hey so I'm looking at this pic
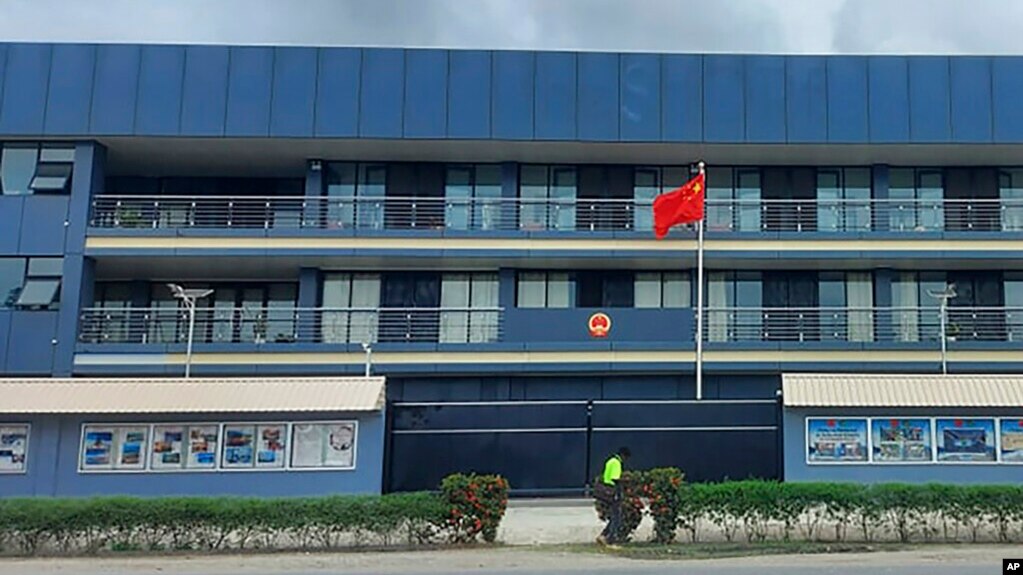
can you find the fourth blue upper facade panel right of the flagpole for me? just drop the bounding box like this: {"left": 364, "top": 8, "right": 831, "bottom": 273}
{"left": 828, "top": 56, "right": 869, "bottom": 143}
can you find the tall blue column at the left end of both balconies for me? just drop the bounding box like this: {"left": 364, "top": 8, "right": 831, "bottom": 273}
{"left": 53, "top": 142, "right": 106, "bottom": 378}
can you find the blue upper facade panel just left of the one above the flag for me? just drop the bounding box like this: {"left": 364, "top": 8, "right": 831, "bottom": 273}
{"left": 618, "top": 54, "right": 661, "bottom": 142}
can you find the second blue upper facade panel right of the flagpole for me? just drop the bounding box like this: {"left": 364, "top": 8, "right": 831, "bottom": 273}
{"left": 746, "top": 56, "right": 787, "bottom": 143}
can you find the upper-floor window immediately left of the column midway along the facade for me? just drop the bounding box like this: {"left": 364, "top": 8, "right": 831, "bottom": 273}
{"left": 444, "top": 165, "right": 501, "bottom": 230}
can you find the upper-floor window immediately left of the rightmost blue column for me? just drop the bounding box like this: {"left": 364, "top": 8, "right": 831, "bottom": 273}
{"left": 817, "top": 168, "right": 871, "bottom": 231}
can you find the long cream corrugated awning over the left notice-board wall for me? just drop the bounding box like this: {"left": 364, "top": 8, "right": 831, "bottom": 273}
{"left": 0, "top": 378, "right": 385, "bottom": 413}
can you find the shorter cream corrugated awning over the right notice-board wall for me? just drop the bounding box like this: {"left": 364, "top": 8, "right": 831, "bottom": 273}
{"left": 782, "top": 373, "right": 1023, "bottom": 407}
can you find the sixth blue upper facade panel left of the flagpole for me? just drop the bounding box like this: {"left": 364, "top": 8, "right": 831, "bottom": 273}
{"left": 447, "top": 50, "right": 492, "bottom": 139}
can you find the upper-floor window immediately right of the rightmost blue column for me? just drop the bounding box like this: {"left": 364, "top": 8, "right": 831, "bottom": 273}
{"left": 887, "top": 168, "right": 945, "bottom": 231}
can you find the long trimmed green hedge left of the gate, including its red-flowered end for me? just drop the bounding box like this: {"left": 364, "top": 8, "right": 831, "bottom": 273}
{"left": 0, "top": 476, "right": 507, "bottom": 555}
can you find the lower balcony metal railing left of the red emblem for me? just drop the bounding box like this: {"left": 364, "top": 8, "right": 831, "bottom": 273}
{"left": 79, "top": 307, "right": 503, "bottom": 345}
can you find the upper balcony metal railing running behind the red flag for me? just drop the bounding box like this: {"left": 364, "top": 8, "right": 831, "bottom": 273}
{"left": 90, "top": 195, "right": 1023, "bottom": 233}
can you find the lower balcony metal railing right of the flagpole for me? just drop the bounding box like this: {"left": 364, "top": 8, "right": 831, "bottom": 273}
{"left": 704, "top": 307, "right": 1023, "bottom": 343}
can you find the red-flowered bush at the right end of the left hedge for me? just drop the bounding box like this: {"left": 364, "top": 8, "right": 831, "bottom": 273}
{"left": 441, "top": 474, "right": 508, "bottom": 543}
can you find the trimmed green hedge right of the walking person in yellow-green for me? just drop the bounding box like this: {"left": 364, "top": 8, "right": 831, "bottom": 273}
{"left": 597, "top": 476, "right": 1023, "bottom": 543}
